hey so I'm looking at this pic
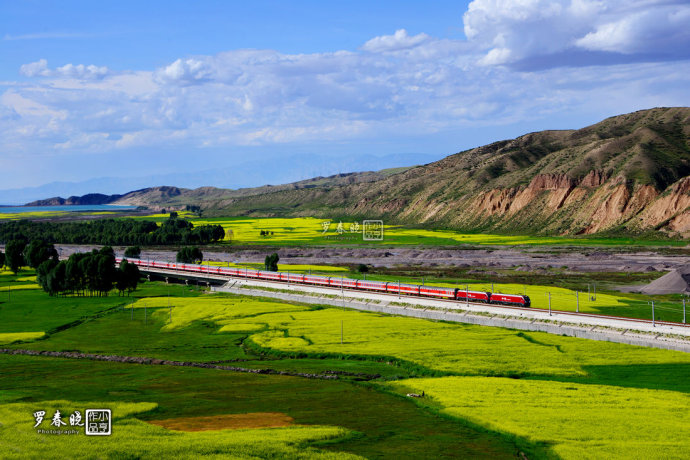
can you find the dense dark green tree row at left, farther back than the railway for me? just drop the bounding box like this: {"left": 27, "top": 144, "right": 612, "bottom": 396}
{"left": 0, "top": 215, "right": 225, "bottom": 246}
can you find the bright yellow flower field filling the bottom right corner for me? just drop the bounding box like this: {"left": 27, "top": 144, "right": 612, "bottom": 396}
{"left": 390, "top": 377, "right": 690, "bottom": 459}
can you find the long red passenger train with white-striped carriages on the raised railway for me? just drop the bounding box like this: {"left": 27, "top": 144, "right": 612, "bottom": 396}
{"left": 116, "top": 258, "right": 530, "bottom": 307}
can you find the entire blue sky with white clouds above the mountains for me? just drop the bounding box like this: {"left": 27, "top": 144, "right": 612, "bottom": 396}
{"left": 0, "top": 0, "right": 690, "bottom": 196}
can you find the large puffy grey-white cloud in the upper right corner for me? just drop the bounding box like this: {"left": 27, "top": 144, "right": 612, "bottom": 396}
{"left": 463, "top": 0, "right": 690, "bottom": 67}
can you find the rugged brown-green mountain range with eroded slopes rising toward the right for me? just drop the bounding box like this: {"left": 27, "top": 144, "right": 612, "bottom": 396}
{"left": 18, "top": 107, "right": 690, "bottom": 236}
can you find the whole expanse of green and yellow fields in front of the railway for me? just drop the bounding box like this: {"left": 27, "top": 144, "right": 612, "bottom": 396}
{"left": 0, "top": 273, "right": 690, "bottom": 459}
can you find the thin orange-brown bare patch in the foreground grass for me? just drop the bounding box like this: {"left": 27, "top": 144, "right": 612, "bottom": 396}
{"left": 149, "top": 412, "right": 294, "bottom": 431}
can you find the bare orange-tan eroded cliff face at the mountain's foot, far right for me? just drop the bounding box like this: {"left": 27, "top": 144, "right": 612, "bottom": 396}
{"left": 460, "top": 171, "right": 690, "bottom": 236}
